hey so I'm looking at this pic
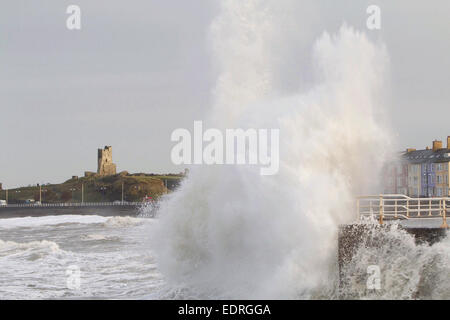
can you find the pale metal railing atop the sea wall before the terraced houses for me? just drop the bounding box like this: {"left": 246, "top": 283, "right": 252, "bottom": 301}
{"left": 356, "top": 194, "right": 450, "bottom": 228}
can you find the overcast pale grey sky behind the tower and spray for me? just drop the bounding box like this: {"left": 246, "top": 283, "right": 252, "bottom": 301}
{"left": 0, "top": 0, "right": 450, "bottom": 188}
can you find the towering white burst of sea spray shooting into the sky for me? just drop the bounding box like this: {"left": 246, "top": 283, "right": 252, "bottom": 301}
{"left": 151, "top": 1, "right": 390, "bottom": 298}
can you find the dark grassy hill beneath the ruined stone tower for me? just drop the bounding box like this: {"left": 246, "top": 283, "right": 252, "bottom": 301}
{"left": 0, "top": 172, "right": 184, "bottom": 203}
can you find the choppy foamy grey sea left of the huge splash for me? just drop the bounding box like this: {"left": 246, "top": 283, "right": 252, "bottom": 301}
{"left": 0, "top": 215, "right": 162, "bottom": 299}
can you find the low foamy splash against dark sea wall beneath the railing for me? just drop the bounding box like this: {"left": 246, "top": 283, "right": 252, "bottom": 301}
{"left": 338, "top": 222, "right": 450, "bottom": 299}
